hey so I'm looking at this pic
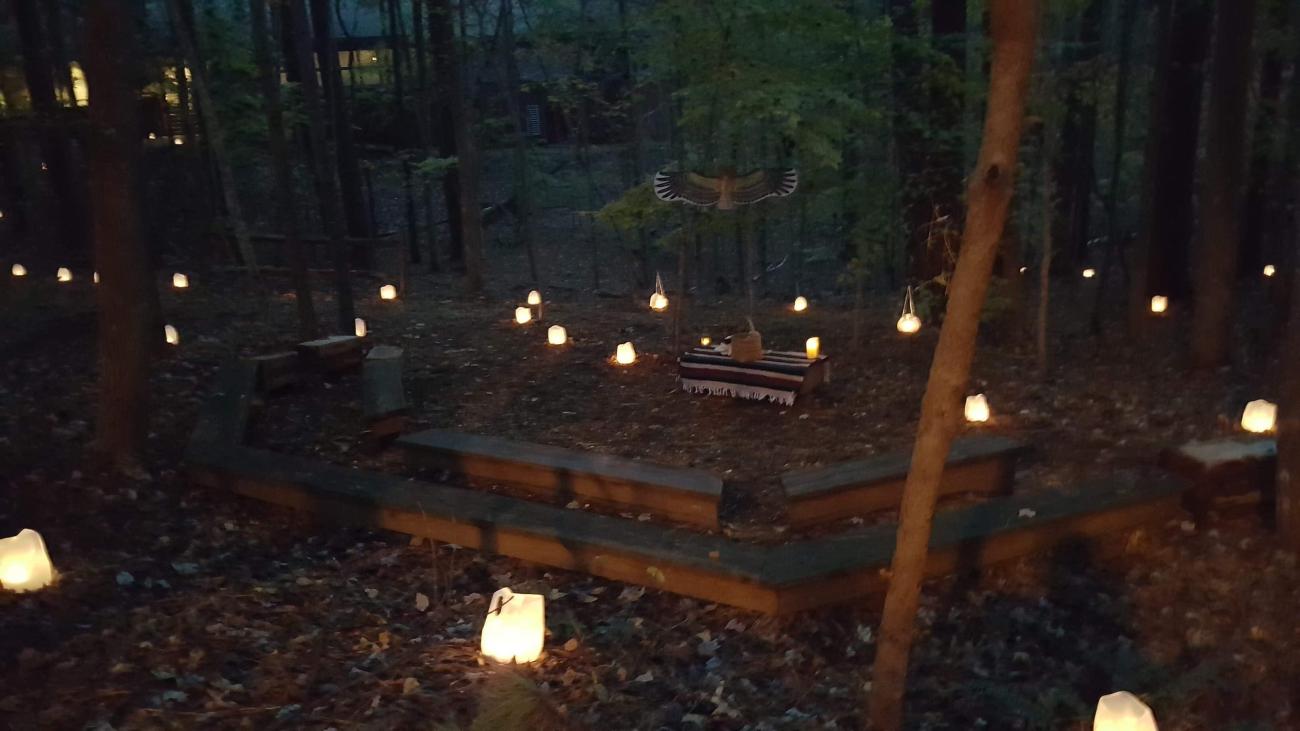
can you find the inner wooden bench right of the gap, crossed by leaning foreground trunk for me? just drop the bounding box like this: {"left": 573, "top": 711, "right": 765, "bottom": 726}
{"left": 781, "top": 434, "right": 1028, "bottom": 528}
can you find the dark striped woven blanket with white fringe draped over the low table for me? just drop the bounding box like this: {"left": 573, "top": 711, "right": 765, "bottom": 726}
{"left": 677, "top": 346, "right": 831, "bottom": 406}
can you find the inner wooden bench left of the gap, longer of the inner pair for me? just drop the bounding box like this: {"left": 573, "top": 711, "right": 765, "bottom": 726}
{"left": 397, "top": 429, "right": 723, "bottom": 528}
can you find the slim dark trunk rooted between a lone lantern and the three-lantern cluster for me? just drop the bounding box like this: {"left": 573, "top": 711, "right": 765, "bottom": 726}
{"left": 429, "top": 0, "right": 484, "bottom": 294}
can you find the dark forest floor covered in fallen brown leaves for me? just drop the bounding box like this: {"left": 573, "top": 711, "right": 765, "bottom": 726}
{"left": 0, "top": 256, "right": 1300, "bottom": 731}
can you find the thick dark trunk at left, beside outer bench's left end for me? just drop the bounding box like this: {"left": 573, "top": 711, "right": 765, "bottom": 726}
{"left": 85, "top": 0, "right": 161, "bottom": 471}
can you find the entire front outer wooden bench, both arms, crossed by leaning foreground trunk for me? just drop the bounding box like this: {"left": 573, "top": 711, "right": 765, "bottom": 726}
{"left": 186, "top": 441, "right": 1186, "bottom": 614}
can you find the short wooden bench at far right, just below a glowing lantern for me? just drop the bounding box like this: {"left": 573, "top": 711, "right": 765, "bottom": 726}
{"left": 1160, "top": 438, "right": 1278, "bottom": 523}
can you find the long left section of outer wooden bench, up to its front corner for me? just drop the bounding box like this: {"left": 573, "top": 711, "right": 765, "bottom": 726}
{"left": 186, "top": 444, "right": 777, "bottom": 613}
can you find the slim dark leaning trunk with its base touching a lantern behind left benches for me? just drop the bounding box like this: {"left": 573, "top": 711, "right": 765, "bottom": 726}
{"left": 286, "top": 0, "right": 356, "bottom": 327}
